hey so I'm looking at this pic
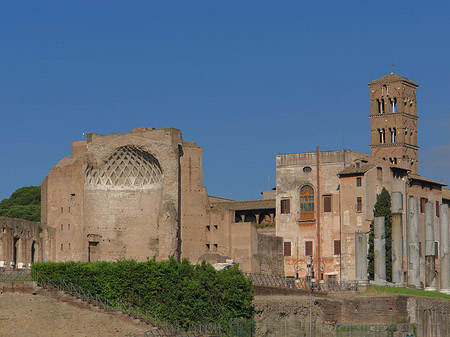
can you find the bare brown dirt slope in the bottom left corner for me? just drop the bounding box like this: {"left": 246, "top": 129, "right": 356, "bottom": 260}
{"left": 0, "top": 293, "right": 149, "bottom": 337}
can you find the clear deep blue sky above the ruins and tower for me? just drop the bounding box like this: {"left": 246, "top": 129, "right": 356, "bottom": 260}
{"left": 0, "top": 0, "right": 450, "bottom": 200}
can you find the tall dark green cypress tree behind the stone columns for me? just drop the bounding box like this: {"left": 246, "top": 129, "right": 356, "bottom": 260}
{"left": 367, "top": 187, "right": 392, "bottom": 282}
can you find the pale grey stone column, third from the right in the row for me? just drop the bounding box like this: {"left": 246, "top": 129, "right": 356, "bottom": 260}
{"left": 408, "top": 197, "right": 420, "bottom": 288}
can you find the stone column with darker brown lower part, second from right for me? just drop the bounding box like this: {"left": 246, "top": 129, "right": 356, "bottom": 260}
{"left": 425, "top": 202, "right": 436, "bottom": 291}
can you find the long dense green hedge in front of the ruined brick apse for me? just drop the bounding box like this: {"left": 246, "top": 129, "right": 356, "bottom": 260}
{"left": 33, "top": 258, "right": 254, "bottom": 327}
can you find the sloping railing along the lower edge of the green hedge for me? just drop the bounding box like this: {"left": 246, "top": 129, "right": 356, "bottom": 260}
{"left": 30, "top": 270, "right": 221, "bottom": 337}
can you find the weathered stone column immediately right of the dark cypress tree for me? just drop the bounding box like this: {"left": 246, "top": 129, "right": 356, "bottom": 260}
{"left": 391, "top": 192, "right": 404, "bottom": 284}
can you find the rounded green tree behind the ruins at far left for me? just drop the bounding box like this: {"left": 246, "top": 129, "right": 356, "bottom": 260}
{"left": 0, "top": 186, "right": 41, "bottom": 222}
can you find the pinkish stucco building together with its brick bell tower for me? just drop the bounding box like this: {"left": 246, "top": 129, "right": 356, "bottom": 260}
{"left": 276, "top": 74, "right": 450, "bottom": 281}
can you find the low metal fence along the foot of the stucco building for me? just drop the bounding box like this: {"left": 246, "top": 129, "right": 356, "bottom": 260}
{"left": 245, "top": 273, "right": 359, "bottom": 291}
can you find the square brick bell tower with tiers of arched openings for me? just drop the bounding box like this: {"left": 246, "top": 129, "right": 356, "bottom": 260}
{"left": 369, "top": 73, "right": 419, "bottom": 174}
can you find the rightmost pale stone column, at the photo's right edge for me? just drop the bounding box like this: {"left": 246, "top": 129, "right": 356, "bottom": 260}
{"left": 439, "top": 204, "right": 450, "bottom": 294}
